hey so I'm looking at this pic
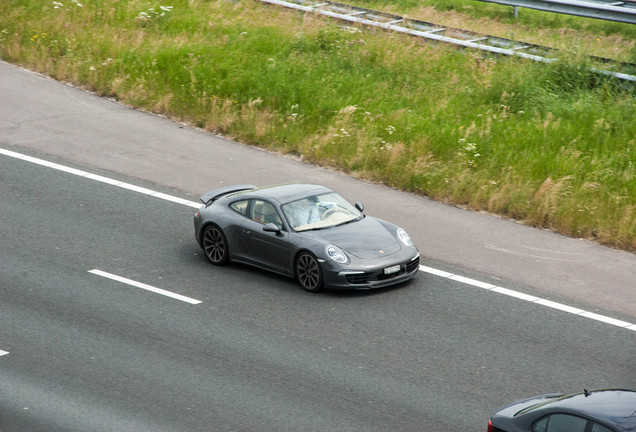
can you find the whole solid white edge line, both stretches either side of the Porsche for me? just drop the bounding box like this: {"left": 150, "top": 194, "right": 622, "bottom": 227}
{"left": 0, "top": 148, "right": 636, "bottom": 331}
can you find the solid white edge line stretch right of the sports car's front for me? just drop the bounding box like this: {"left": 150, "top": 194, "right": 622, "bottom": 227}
{"left": 420, "top": 265, "right": 636, "bottom": 331}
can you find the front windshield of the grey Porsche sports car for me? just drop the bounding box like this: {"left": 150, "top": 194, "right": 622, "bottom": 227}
{"left": 282, "top": 192, "right": 362, "bottom": 231}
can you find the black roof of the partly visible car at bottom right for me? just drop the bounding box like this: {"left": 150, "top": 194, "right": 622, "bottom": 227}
{"left": 517, "top": 389, "right": 636, "bottom": 430}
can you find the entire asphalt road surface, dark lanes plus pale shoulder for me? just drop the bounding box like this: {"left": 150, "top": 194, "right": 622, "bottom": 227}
{"left": 0, "top": 63, "right": 636, "bottom": 432}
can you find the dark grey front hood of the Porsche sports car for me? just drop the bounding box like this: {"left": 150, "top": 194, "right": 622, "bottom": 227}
{"left": 303, "top": 216, "right": 400, "bottom": 259}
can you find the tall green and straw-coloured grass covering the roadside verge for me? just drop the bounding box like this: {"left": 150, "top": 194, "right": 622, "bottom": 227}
{"left": 0, "top": 0, "right": 636, "bottom": 251}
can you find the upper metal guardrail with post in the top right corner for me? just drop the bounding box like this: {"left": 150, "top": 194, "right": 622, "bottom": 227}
{"left": 479, "top": 0, "right": 636, "bottom": 24}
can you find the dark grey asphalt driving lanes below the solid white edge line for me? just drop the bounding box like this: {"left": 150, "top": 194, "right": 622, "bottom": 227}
{"left": 0, "top": 143, "right": 636, "bottom": 432}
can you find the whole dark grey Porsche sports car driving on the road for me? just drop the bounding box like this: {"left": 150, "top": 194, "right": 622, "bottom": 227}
{"left": 194, "top": 184, "right": 420, "bottom": 292}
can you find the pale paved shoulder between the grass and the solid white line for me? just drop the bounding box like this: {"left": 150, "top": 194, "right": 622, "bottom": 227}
{"left": 0, "top": 58, "right": 636, "bottom": 322}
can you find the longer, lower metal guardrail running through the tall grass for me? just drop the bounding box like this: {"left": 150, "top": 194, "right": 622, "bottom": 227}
{"left": 259, "top": 0, "right": 636, "bottom": 82}
